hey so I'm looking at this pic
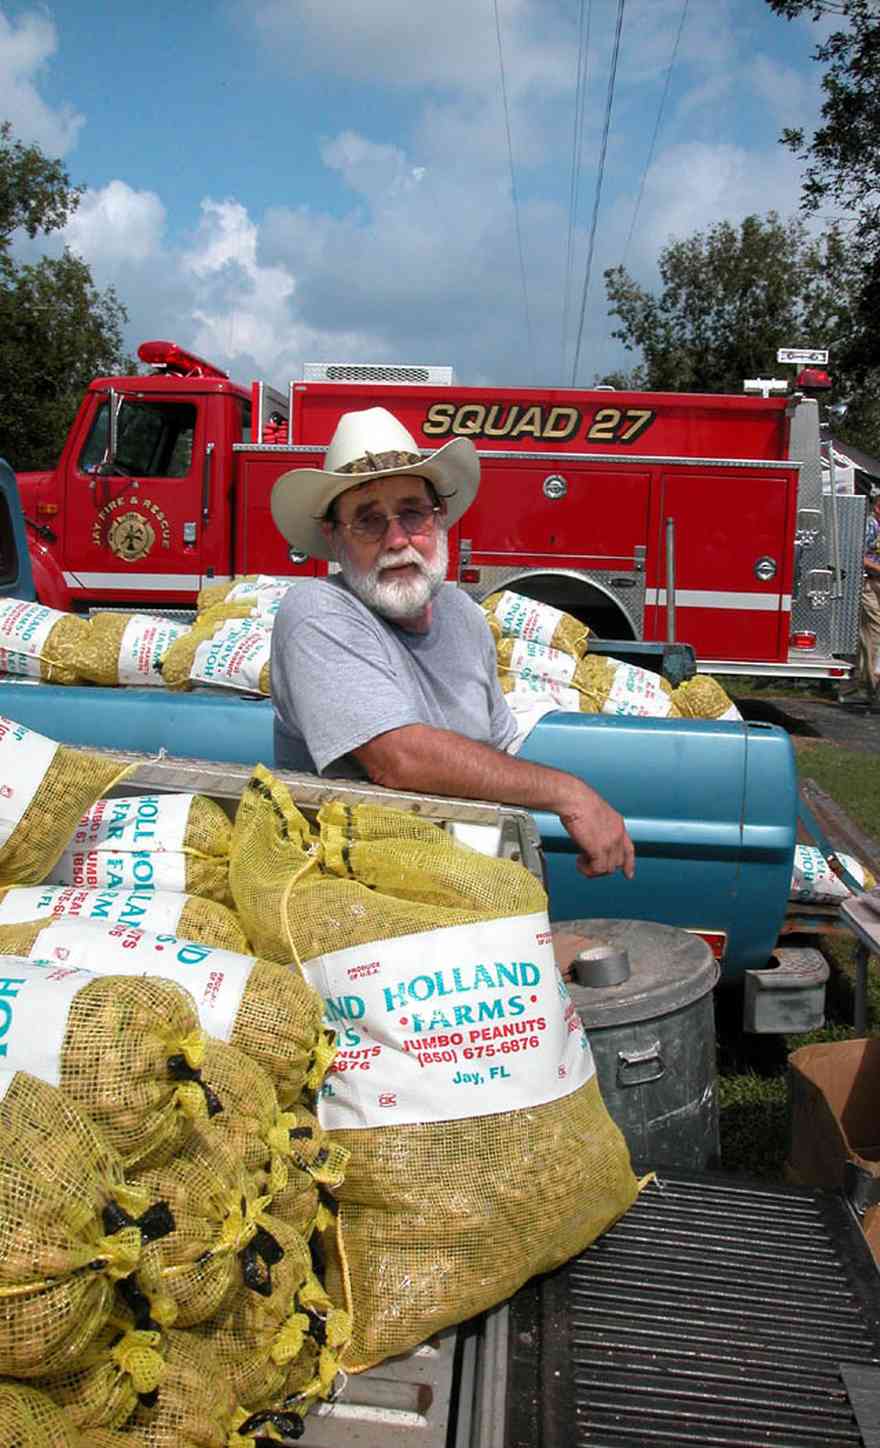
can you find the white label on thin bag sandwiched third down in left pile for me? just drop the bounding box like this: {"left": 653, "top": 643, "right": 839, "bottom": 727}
{"left": 0, "top": 885, "right": 190, "bottom": 934}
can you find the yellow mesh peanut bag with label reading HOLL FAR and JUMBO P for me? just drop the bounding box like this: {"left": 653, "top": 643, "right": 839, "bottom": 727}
{"left": 45, "top": 788, "right": 232, "bottom": 904}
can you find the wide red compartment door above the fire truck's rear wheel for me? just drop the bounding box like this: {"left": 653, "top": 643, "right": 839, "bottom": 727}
{"left": 462, "top": 453, "right": 650, "bottom": 571}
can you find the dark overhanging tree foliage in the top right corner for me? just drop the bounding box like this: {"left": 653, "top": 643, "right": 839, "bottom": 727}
{"left": 767, "top": 0, "right": 880, "bottom": 388}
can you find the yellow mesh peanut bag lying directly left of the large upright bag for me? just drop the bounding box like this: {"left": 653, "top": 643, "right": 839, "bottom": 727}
{"left": 0, "top": 917, "right": 333, "bottom": 1106}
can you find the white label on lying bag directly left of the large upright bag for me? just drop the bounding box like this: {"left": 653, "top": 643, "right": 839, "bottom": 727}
{"left": 29, "top": 919, "right": 253, "bottom": 1041}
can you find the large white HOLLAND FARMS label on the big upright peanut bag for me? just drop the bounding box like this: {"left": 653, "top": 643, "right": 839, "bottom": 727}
{"left": 303, "top": 912, "right": 595, "bottom": 1131}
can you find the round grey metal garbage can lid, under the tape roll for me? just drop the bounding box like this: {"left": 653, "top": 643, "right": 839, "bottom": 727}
{"left": 551, "top": 919, "right": 721, "bottom": 1030}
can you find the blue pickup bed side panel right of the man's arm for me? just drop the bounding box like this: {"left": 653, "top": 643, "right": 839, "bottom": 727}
{"left": 520, "top": 712, "right": 798, "bottom": 980}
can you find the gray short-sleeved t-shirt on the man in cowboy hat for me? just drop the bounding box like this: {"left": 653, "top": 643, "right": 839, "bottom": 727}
{"left": 272, "top": 576, "right": 517, "bottom": 778}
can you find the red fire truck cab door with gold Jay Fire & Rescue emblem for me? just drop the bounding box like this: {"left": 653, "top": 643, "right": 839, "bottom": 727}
{"left": 64, "top": 397, "right": 205, "bottom": 602}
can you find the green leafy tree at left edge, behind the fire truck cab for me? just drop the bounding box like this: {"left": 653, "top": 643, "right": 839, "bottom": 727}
{"left": 0, "top": 123, "right": 132, "bottom": 469}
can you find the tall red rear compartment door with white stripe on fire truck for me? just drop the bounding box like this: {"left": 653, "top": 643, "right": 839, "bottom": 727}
{"left": 646, "top": 469, "right": 796, "bottom": 662}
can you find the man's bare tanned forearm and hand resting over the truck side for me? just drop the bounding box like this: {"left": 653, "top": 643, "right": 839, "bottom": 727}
{"left": 355, "top": 724, "right": 634, "bottom": 876}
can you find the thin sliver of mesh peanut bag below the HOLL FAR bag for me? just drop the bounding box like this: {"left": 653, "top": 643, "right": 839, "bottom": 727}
{"left": 0, "top": 885, "right": 250, "bottom": 954}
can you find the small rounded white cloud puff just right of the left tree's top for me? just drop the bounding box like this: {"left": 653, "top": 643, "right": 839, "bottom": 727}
{"left": 64, "top": 181, "right": 165, "bottom": 271}
